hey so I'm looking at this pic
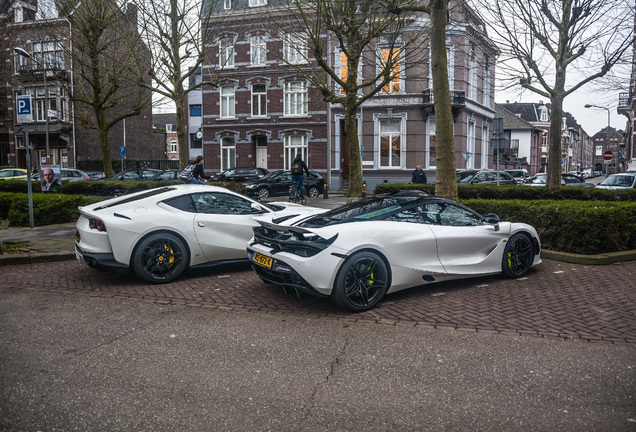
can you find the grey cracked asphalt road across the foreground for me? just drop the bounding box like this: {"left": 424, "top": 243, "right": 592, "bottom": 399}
{"left": 0, "top": 278, "right": 636, "bottom": 431}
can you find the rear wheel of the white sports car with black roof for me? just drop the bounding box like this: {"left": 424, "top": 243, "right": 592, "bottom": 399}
{"left": 331, "top": 251, "right": 390, "bottom": 312}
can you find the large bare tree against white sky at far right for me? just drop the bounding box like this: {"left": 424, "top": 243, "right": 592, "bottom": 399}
{"left": 475, "top": 0, "right": 634, "bottom": 187}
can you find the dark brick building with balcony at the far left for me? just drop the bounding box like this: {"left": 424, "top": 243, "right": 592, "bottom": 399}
{"left": 0, "top": 0, "right": 163, "bottom": 169}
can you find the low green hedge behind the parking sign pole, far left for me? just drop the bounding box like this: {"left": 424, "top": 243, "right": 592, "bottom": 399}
{"left": 7, "top": 192, "right": 99, "bottom": 226}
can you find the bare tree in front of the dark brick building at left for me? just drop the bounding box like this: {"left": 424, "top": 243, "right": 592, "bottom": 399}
{"left": 59, "top": 0, "right": 151, "bottom": 176}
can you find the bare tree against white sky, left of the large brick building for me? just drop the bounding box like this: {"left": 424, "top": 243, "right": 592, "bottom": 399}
{"left": 133, "top": 0, "right": 238, "bottom": 169}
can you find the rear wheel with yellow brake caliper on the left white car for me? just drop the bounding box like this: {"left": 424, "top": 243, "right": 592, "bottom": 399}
{"left": 133, "top": 232, "right": 189, "bottom": 283}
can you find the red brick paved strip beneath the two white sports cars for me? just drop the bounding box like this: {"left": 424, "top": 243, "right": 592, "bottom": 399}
{"left": 2, "top": 261, "right": 636, "bottom": 344}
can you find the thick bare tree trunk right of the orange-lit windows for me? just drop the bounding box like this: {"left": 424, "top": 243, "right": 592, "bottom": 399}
{"left": 431, "top": 0, "right": 458, "bottom": 200}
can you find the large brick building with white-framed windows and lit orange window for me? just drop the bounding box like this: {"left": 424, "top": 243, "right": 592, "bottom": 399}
{"left": 202, "top": 0, "right": 498, "bottom": 189}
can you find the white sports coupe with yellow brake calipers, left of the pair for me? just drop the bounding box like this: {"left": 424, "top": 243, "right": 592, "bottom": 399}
{"left": 75, "top": 185, "right": 324, "bottom": 283}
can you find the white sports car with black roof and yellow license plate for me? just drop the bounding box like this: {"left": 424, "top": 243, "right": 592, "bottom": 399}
{"left": 247, "top": 191, "right": 541, "bottom": 311}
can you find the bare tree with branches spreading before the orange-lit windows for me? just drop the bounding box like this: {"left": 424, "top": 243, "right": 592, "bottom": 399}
{"left": 279, "top": 0, "right": 428, "bottom": 196}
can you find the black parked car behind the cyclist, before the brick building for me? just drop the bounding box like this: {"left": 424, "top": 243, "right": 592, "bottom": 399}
{"left": 245, "top": 170, "right": 325, "bottom": 199}
